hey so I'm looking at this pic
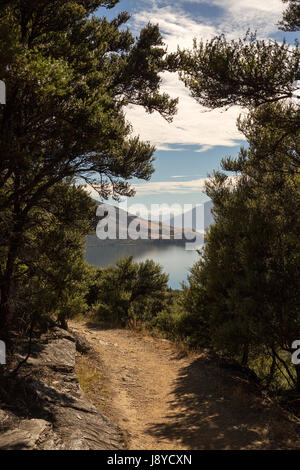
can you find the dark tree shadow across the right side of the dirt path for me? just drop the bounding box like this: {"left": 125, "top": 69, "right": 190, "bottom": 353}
{"left": 148, "top": 357, "right": 296, "bottom": 450}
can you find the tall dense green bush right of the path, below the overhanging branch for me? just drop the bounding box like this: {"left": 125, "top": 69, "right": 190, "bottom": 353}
{"left": 185, "top": 111, "right": 300, "bottom": 386}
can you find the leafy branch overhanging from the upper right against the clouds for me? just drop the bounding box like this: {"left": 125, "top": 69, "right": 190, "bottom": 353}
{"left": 169, "top": 35, "right": 300, "bottom": 109}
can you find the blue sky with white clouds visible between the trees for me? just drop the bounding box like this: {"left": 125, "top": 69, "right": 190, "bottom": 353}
{"left": 97, "top": 0, "right": 295, "bottom": 213}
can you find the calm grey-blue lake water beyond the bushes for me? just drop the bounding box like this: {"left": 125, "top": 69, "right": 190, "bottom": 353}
{"left": 86, "top": 242, "right": 199, "bottom": 289}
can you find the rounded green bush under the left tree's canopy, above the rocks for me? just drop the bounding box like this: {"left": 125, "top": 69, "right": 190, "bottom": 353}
{"left": 0, "top": 183, "right": 96, "bottom": 325}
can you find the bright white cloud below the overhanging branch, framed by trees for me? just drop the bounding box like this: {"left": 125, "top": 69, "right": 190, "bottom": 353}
{"left": 127, "top": 72, "right": 243, "bottom": 152}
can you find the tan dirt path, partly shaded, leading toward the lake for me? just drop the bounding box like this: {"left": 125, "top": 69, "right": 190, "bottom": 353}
{"left": 70, "top": 322, "right": 300, "bottom": 450}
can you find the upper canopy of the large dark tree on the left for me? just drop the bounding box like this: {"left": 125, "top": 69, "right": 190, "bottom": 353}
{"left": 0, "top": 1, "right": 176, "bottom": 200}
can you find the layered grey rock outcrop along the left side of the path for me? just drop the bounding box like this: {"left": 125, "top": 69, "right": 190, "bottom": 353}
{"left": 0, "top": 328, "right": 124, "bottom": 450}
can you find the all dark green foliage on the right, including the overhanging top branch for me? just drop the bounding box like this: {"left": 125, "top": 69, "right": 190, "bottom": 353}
{"left": 173, "top": 1, "right": 300, "bottom": 390}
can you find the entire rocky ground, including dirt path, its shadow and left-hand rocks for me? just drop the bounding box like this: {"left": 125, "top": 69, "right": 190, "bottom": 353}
{"left": 0, "top": 322, "right": 300, "bottom": 450}
